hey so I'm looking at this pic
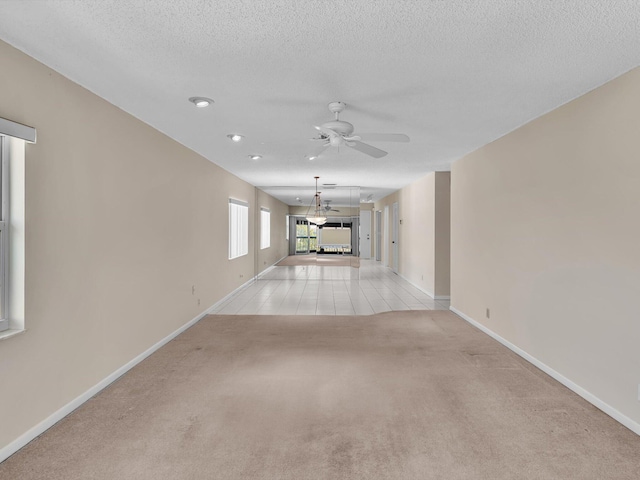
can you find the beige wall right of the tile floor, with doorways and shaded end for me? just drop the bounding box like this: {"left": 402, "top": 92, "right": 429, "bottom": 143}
{"left": 374, "top": 172, "right": 451, "bottom": 297}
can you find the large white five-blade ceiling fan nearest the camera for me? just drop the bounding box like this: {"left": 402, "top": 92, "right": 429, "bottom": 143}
{"left": 308, "top": 102, "right": 409, "bottom": 160}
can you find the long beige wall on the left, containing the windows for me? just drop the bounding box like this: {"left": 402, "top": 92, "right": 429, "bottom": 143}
{"left": 0, "top": 42, "right": 286, "bottom": 448}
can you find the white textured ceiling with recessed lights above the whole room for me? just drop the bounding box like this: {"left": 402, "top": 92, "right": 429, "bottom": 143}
{"left": 0, "top": 0, "right": 640, "bottom": 205}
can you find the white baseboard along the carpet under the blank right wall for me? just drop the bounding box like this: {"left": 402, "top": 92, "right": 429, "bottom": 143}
{"left": 449, "top": 307, "right": 640, "bottom": 435}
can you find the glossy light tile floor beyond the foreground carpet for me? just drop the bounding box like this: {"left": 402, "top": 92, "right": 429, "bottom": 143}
{"left": 211, "top": 260, "right": 449, "bottom": 315}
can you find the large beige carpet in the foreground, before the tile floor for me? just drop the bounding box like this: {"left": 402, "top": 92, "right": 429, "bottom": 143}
{"left": 0, "top": 311, "right": 640, "bottom": 480}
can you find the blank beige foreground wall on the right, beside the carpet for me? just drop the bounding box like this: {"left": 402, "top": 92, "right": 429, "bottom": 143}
{"left": 451, "top": 65, "right": 640, "bottom": 430}
